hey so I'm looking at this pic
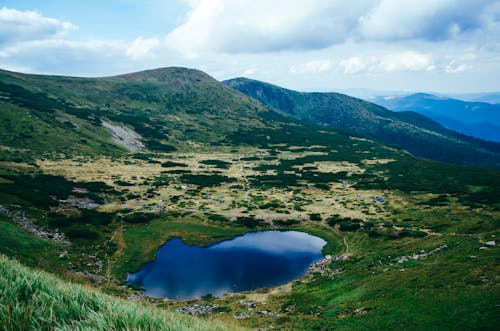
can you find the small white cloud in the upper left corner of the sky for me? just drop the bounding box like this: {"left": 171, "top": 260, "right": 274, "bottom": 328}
{"left": 0, "top": 7, "right": 76, "bottom": 45}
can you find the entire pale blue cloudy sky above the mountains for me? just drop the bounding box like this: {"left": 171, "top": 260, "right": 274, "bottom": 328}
{"left": 0, "top": 0, "right": 500, "bottom": 93}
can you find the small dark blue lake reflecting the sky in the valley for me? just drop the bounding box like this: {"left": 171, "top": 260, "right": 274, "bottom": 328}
{"left": 127, "top": 231, "right": 326, "bottom": 300}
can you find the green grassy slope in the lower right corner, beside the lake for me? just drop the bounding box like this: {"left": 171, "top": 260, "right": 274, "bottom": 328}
{"left": 283, "top": 234, "right": 500, "bottom": 330}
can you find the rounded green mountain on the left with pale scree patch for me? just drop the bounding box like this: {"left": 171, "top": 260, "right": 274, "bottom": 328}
{"left": 0, "top": 68, "right": 282, "bottom": 160}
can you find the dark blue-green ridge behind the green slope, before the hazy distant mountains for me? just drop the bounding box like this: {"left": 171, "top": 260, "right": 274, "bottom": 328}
{"left": 224, "top": 78, "right": 500, "bottom": 167}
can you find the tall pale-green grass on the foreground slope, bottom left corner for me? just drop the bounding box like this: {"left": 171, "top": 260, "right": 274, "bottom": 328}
{"left": 0, "top": 255, "right": 240, "bottom": 331}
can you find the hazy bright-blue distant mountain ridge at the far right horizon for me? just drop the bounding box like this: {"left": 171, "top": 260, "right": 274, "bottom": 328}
{"left": 373, "top": 93, "right": 500, "bottom": 142}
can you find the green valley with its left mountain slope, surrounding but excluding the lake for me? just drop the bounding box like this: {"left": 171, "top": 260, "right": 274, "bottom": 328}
{"left": 0, "top": 68, "right": 500, "bottom": 330}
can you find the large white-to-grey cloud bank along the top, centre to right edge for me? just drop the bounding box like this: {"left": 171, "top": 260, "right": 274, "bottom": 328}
{"left": 168, "top": 0, "right": 498, "bottom": 55}
